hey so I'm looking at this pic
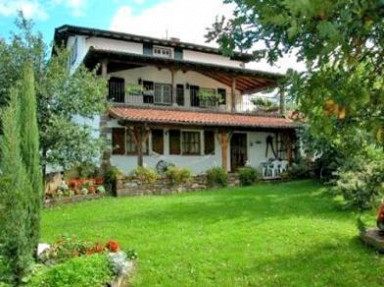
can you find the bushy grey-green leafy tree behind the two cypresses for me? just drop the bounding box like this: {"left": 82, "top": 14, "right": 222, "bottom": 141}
{"left": 0, "top": 15, "right": 107, "bottom": 177}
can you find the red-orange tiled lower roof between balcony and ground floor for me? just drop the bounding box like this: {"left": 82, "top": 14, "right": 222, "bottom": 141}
{"left": 109, "top": 107, "right": 297, "bottom": 129}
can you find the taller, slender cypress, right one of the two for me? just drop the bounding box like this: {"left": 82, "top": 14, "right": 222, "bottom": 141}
{"left": 19, "top": 63, "right": 43, "bottom": 254}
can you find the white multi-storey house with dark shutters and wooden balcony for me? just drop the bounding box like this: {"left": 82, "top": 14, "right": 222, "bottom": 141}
{"left": 55, "top": 25, "right": 297, "bottom": 177}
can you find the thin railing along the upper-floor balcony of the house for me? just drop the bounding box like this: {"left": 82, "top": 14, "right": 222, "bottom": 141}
{"left": 109, "top": 92, "right": 262, "bottom": 113}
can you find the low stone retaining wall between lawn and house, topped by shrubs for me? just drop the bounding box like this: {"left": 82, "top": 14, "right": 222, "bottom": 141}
{"left": 116, "top": 174, "right": 240, "bottom": 196}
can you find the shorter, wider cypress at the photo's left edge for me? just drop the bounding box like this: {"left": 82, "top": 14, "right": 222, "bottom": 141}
{"left": 0, "top": 92, "right": 32, "bottom": 285}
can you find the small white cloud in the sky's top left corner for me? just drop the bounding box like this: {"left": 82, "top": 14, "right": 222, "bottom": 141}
{"left": 0, "top": 0, "right": 48, "bottom": 20}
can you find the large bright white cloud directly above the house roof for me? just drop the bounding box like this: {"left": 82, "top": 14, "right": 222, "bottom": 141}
{"left": 110, "top": 0, "right": 304, "bottom": 73}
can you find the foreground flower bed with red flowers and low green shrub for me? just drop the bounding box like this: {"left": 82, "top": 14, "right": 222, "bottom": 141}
{"left": 27, "top": 237, "right": 137, "bottom": 287}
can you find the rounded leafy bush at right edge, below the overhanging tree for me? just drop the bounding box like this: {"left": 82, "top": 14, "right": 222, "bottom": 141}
{"left": 332, "top": 147, "right": 384, "bottom": 210}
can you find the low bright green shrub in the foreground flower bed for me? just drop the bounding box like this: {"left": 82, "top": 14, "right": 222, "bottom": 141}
{"left": 28, "top": 254, "right": 113, "bottom": 287}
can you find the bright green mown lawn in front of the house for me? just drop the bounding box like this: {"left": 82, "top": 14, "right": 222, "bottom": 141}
{"left": 42, "top": 181, "right": 384, "bottom": 287}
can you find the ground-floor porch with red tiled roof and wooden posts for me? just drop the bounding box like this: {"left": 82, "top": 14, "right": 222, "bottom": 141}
{"left": 107, "top": 107, "right": 297, "bottom": 177}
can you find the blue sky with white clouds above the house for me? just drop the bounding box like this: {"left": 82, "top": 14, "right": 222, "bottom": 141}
{"left": 0, "top": 0, "right": 303, "bottom": 73}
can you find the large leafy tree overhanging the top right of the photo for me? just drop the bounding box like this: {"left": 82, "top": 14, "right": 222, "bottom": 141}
{"left": 206, "top": 0, "right": 384, "bottom": 154}
